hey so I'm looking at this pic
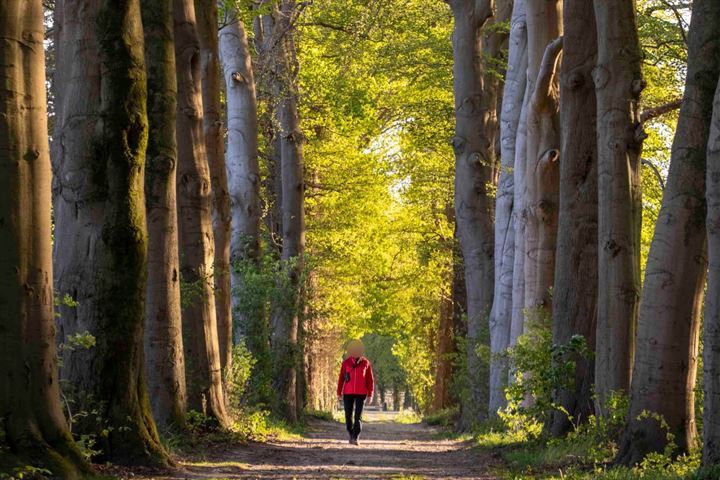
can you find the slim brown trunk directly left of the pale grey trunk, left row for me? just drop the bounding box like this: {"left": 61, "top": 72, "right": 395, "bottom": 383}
{"left": 195, "top": 0, "right": 232, "bottom": 372}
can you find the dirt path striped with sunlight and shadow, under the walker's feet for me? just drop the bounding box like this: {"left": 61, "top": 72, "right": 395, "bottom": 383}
{"left": 115, "top": 411, "right": 499, "bottom": 480}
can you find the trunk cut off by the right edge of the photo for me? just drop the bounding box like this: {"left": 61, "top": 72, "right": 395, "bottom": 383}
{"left": 702, "top": 72, "right": 720, "bottom": 467}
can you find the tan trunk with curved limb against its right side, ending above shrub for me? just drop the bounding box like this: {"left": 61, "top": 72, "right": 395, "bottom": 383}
{"left": 524, "top": 0, "right": 562, "bottom": 314}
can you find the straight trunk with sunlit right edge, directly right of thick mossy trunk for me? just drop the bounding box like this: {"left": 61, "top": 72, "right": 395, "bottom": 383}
{"left": 142, "top": 0, "right": 187, "bottom": 430}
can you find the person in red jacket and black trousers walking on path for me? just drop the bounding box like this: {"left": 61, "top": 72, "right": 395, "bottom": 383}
{"left": 337, "top": 339, "right": 375, "bottom": 445}
